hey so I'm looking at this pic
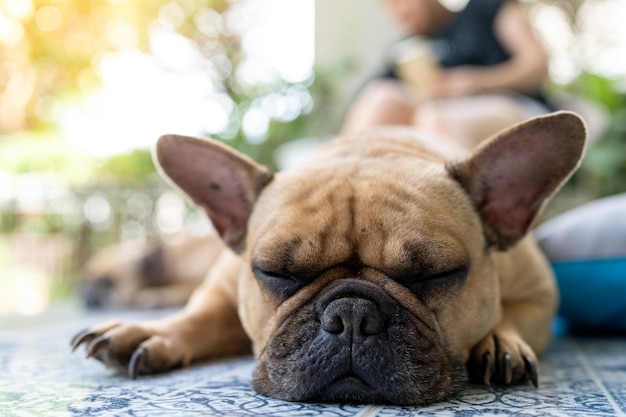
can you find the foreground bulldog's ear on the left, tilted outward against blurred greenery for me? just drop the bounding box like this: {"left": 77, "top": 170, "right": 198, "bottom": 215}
{"left": 154, "top": 135, "right": 274, "bottom": 252}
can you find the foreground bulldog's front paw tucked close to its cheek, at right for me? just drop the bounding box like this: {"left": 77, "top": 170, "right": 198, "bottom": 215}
{"left": 467, "top": 331, "right": 539, "bottom": 387}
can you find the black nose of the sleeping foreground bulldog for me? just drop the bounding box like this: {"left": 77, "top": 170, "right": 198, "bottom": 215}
{"left": 320, "top": 297, "right": 385, "bottom": 343}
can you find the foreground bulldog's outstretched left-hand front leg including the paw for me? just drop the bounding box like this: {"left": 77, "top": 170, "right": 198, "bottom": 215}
{"left": 72, "top": 250, "right": 250, "bottom": 378}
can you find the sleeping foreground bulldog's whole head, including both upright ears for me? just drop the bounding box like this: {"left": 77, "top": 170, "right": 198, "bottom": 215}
{"left": 156, "top": 113, "right": 585, "bottom": 404}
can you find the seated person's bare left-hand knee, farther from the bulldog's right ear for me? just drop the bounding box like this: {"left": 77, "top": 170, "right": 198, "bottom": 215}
{"left": 341, "top": 79, "right": 415, "bottom": 133}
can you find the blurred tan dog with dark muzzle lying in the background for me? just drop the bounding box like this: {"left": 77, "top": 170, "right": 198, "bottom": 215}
{"left": 80, "top": 234, "right": 219, "bottom": 309}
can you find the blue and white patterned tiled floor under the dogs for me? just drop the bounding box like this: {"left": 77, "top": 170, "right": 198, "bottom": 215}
{"left": 0, "top": 306, "right": 626, "bottom": 417}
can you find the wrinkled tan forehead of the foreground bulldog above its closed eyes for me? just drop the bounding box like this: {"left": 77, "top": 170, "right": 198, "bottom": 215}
{"left": 249, "top": 164, "right": 480, "bottom": 272}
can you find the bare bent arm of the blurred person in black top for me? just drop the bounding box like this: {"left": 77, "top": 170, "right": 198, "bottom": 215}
{"left": 434, "top": 1, "right": 548, "bottom": 96}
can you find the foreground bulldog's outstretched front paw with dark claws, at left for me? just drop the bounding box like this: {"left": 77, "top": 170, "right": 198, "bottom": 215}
{"left": 71, "top": 322, "right": 191, "bottom": 379}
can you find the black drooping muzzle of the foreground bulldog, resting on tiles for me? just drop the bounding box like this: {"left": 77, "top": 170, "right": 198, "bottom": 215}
{"left": 253, "top": 279, "right": 463, "bottom": 404}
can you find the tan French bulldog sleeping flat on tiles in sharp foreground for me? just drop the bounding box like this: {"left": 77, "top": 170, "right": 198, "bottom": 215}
{"left": 72, "top": 112, "right": 586, "bottom": 405}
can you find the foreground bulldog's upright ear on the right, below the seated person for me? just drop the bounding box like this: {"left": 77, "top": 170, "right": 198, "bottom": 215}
{"left": 447, "top": 112, "right": 587, "bottom": 249}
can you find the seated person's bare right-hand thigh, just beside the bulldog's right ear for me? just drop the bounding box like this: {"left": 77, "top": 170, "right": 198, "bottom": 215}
{"left": 413, "top": 94, "right": 540, "bottom": 149}
